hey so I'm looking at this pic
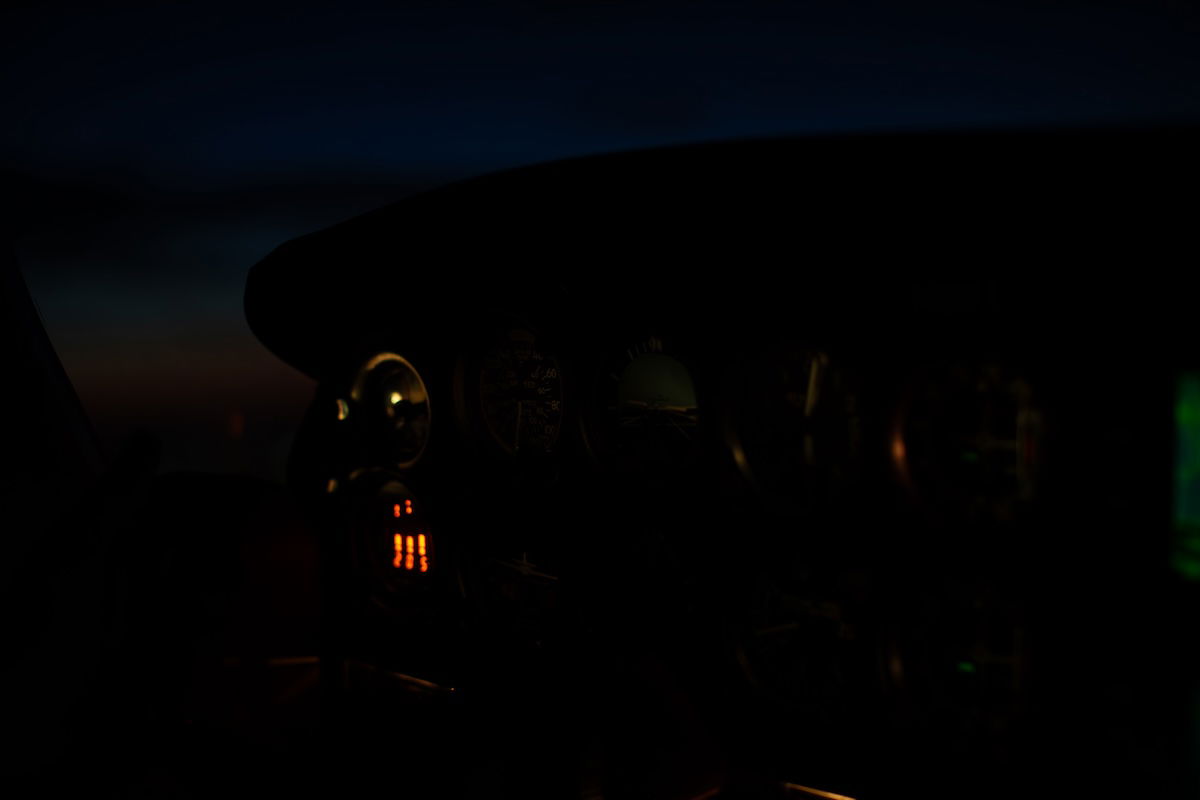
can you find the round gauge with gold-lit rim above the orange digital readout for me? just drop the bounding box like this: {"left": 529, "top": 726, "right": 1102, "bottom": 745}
{"left": 350, "top": 353, "right": 430, "bottom": 468}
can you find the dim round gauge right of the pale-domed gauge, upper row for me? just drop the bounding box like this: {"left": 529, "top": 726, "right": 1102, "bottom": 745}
{"left": 728, "top": 347, "right": 860, "bottom": 509}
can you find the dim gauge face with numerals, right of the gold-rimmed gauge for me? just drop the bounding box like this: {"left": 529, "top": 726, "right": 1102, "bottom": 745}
{"left": 479, "top": 330, "right": 563, "bottom": 455}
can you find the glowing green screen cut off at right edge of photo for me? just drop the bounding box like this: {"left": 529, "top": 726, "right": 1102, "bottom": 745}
{"left": 1171, "top": 372, "right": 1200, "bottom": 581}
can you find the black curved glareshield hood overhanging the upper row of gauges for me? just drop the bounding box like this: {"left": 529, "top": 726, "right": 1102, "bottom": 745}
{"left": 245, "top": 130, "right": 1196, "bottom": 378}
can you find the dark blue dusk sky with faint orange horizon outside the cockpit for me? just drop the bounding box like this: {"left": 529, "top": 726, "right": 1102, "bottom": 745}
{"left": 0, "top": 0, "right": 1200, "bottom": 479}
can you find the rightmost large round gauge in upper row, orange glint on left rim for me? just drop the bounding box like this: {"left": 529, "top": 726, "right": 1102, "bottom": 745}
{"left": 892, "top": 365, "right": 1043, "bottom": 521}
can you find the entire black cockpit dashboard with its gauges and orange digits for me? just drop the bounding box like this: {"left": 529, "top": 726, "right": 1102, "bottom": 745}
{"left": 246, "top": 131, "right": 1200, "bottom": 798}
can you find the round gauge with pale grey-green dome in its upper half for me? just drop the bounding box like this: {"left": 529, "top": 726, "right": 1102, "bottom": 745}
{"left": 600, "top": 337, "right": 700, "bottom": 471}
